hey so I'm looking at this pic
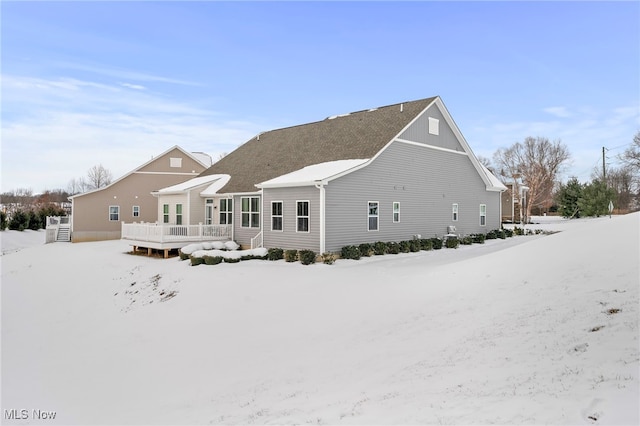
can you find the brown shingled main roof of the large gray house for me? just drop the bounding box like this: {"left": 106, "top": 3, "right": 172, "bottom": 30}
{"left": 200, "top": 97, "right": 436, "bottom": 193}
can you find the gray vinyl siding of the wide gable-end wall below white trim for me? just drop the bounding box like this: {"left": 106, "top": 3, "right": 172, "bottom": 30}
{"left": 326, "top": 140, "right": 500, "bottom": 251}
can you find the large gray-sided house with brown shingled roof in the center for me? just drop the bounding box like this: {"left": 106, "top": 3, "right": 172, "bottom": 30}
{"left": 123, "top": 97, "right": 506, "bottom": 253}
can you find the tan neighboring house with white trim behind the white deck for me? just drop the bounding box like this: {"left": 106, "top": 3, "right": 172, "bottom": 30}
{"left": 69, "top": 146, "right": 211, "bottom": 242}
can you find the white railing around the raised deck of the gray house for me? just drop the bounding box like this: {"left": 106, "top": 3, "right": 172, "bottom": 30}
{"left": 121, "top": 222, "right": 231, "bottom": 243}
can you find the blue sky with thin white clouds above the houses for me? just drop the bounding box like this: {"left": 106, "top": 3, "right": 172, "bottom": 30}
{"left": 0, "top": 1, "right": 640, "bottom": 192}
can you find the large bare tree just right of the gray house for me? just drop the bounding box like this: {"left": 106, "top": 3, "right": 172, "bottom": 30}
{"left": 493, "top": 137, "right": 571, "bottom": 218}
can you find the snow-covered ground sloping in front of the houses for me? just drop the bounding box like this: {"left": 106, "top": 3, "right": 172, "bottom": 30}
{"left": 0, "top": 213, "right": 640, "bottom": 425}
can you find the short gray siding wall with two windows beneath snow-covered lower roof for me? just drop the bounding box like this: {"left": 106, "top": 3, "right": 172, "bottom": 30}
{"left": 263, "top": 186, "right": 320, "bottom": 253}
